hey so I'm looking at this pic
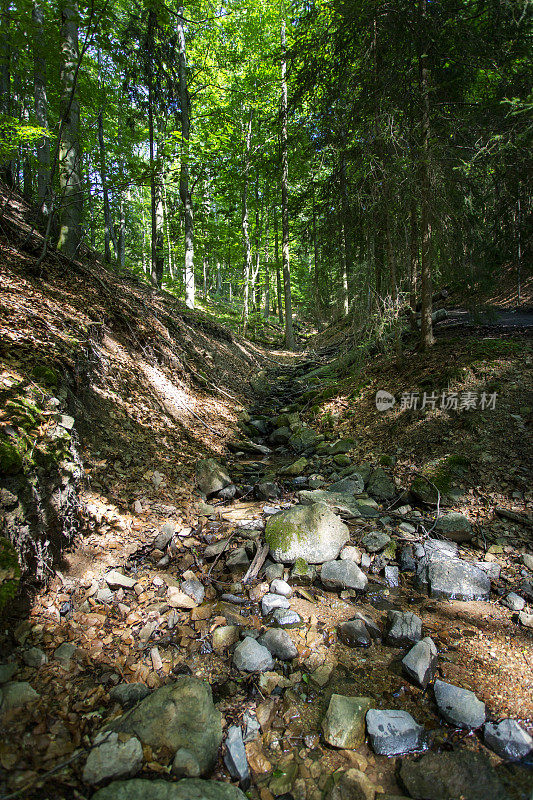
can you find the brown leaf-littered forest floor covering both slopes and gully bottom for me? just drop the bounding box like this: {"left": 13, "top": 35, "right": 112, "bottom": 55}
{"left": 0, "top": 184, "right": 533, "bottom": 800}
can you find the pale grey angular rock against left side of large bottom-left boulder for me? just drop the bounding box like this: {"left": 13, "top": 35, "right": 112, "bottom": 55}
{"left": 83, "top": 732, "right": 143, "bottom": 786}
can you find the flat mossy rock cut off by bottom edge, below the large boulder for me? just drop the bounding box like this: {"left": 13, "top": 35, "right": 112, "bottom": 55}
{"left": 93, "top": 778, "right": 246, "bottom": 800}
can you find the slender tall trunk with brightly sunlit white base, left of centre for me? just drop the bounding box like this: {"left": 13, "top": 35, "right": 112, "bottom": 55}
{"left": 178, "top": 6, "right": 195, "bottom": 308}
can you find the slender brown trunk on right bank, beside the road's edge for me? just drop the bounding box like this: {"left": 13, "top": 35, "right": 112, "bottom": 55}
{"left": 418, "top": 0, "right": 435, "bottom": 350}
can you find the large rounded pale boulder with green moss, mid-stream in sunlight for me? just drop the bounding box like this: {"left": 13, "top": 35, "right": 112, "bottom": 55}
{"left": 265, "top": 503, "right": 349, "bottom": 564}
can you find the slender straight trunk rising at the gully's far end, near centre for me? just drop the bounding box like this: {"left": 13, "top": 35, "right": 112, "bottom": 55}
{"left": 281, "top": 20, "right": 294, "bottom": 350}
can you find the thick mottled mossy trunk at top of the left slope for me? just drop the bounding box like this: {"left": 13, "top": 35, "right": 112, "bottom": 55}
{"left": 57, "top": 0, "right": 83, "bottom": 258}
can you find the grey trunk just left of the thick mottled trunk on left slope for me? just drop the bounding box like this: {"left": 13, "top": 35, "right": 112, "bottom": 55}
{"left": 32, "top": 0, "right": 50, "bottom": 214}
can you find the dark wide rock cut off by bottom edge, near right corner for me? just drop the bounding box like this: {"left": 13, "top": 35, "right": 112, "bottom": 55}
{"left": 400, "top": 748, "right": 509, "bottom": 800}
